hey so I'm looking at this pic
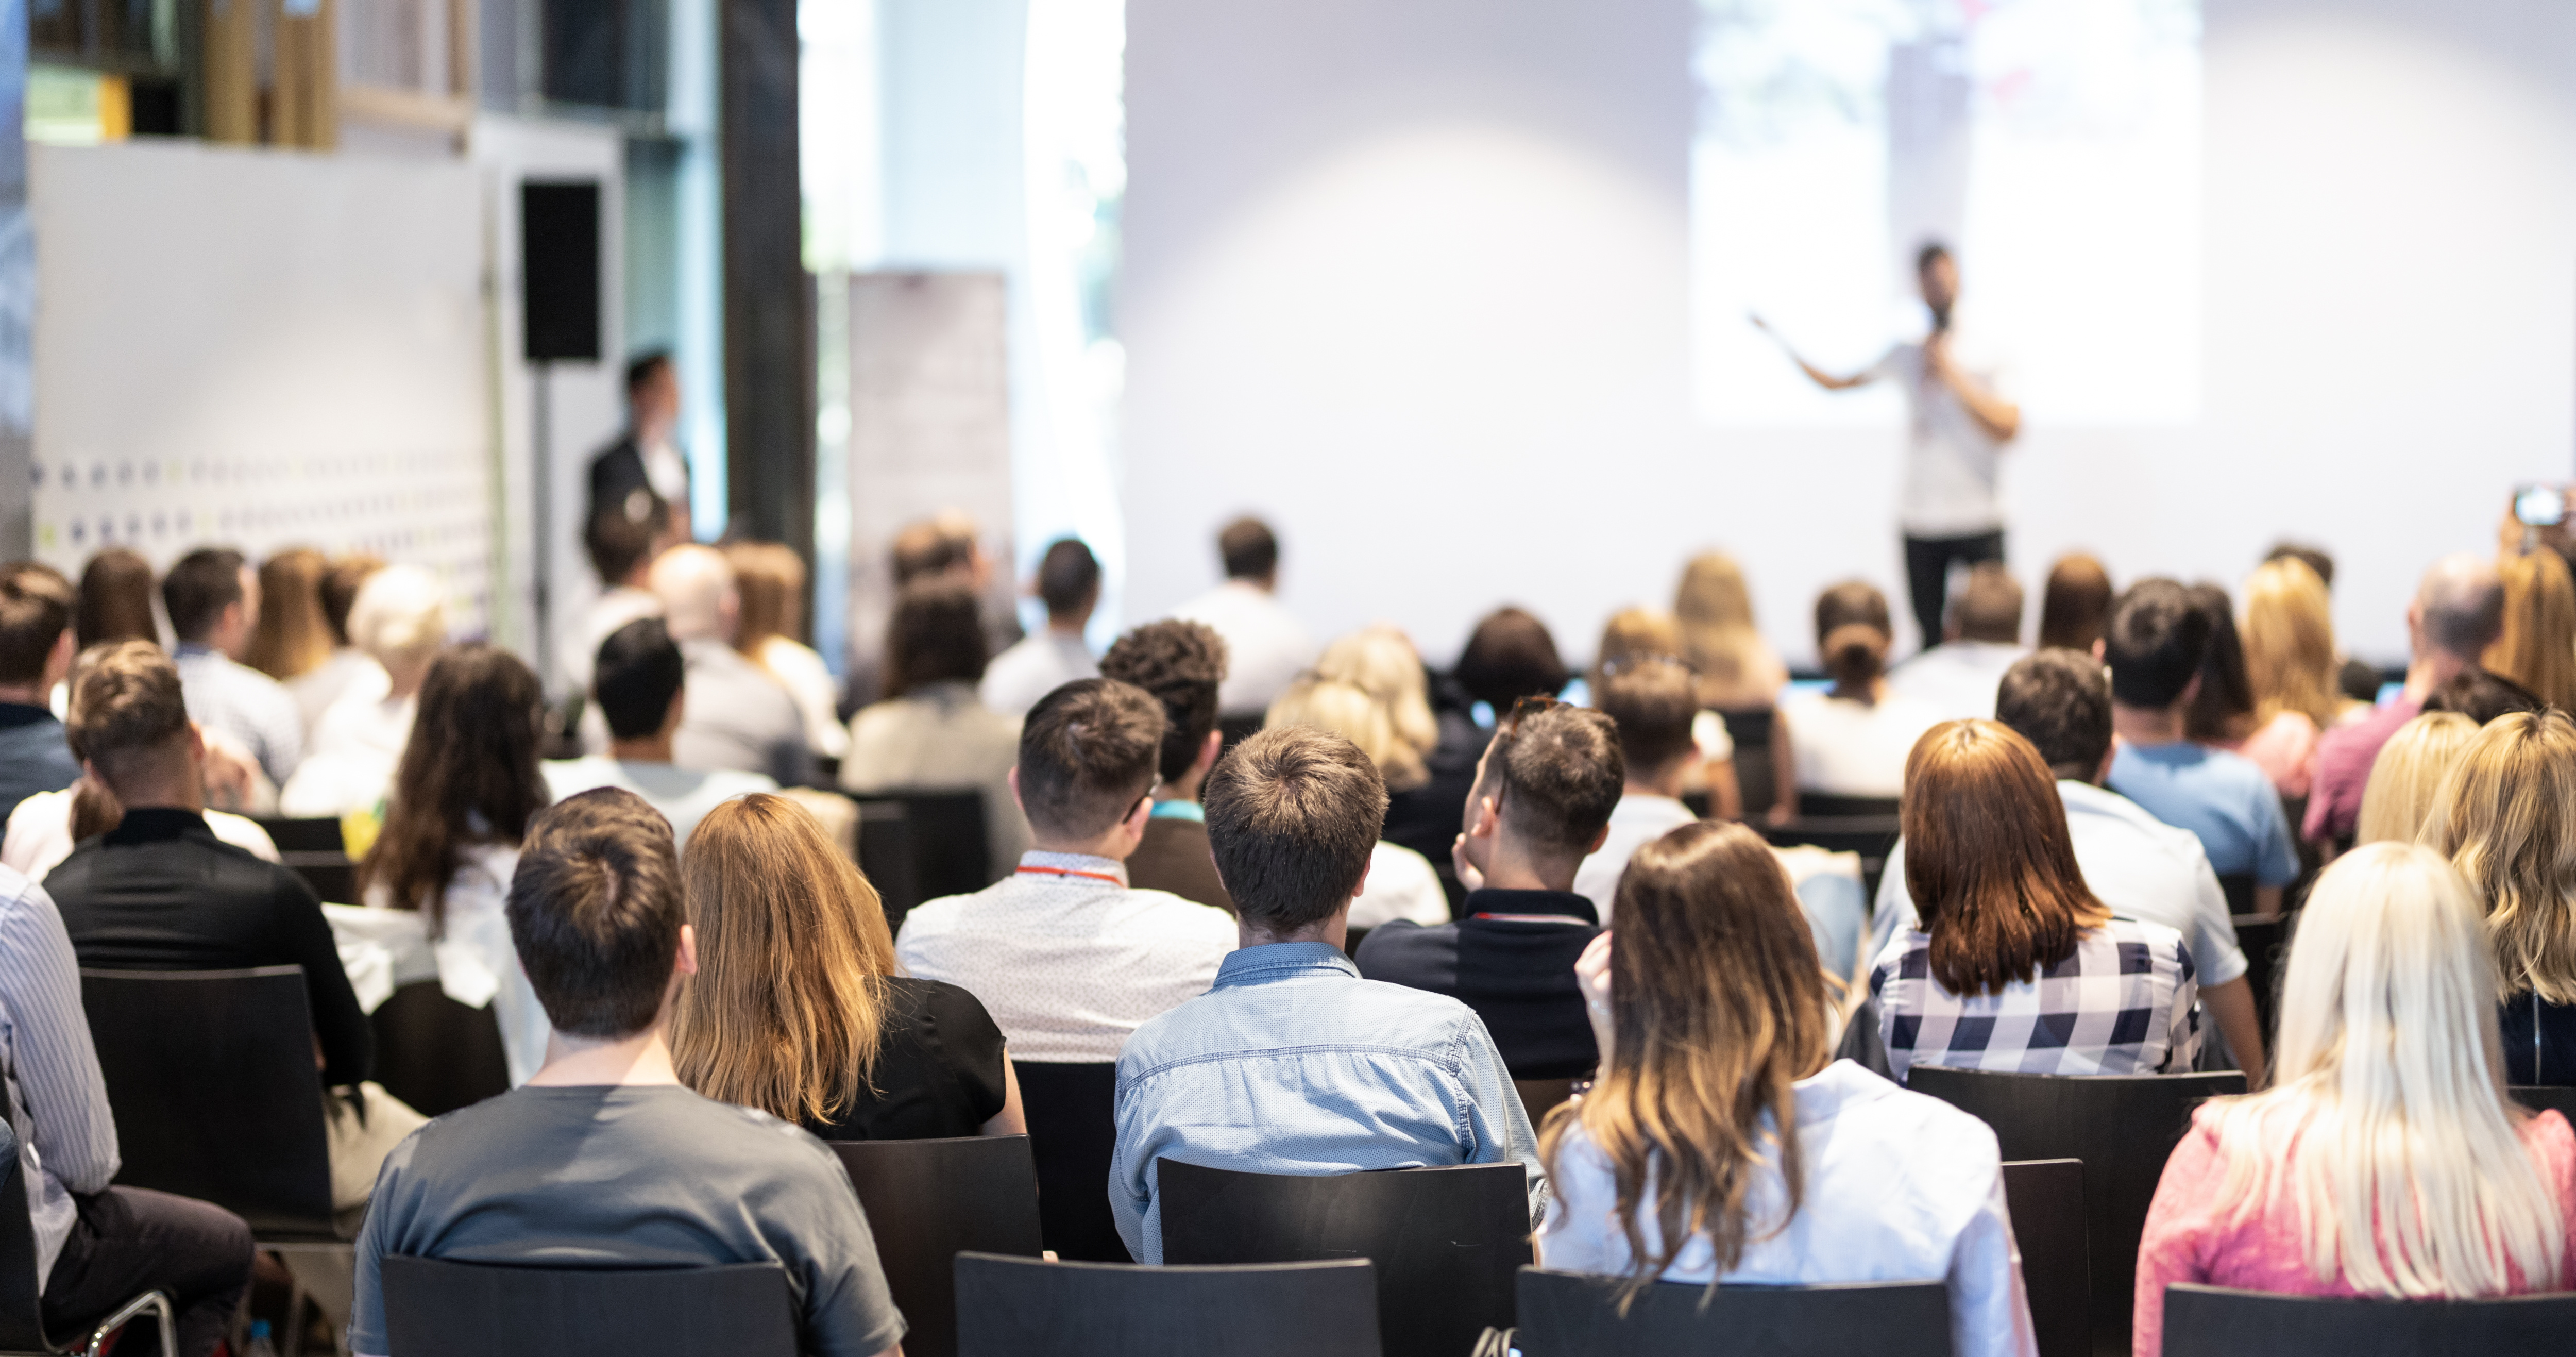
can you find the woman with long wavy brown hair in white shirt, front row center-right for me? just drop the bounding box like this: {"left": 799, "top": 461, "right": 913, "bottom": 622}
{"left": 1538, "top": 822, "right": 2032, "bottom": 1357}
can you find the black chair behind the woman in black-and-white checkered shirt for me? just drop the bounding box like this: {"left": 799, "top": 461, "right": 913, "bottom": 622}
{"left": 1906, "top": 1066, "right": 2246, "bottom": 1352}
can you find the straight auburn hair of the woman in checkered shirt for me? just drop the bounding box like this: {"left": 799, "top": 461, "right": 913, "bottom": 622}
{"left": 1901, "top": 721, "right": 2110, "bottom": 994}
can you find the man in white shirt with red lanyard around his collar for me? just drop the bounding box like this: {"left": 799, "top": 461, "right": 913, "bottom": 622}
{"left": 894, "top": 677, "right": 1234, "bottom": 1063}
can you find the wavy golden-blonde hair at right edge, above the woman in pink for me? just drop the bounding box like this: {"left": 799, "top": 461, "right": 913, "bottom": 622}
{"left": 2416, "top": 711, "right": 2576, "bottom": 1004}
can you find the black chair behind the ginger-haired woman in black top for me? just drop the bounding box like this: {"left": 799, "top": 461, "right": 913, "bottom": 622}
{"left": 832, "top": 1135, "right": 1041, "bottom": 1357}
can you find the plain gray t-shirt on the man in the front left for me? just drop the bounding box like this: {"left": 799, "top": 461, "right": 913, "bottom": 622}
{"left": 348, "top": 1084, "right": 904, "bottom": 1357}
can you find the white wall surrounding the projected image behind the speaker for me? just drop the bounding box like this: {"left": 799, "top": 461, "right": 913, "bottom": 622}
{"left": 1121, "top": 0, "right": 2576, "bottom": 659}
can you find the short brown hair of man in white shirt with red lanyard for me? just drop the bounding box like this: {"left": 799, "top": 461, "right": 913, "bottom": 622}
{"left": 1020, "top": 680, "right": 1167, "bottom": 840}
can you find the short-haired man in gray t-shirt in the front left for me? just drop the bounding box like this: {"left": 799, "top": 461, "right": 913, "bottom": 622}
{"left": 348, "top": 788, "right": 904, "bottom": 1357}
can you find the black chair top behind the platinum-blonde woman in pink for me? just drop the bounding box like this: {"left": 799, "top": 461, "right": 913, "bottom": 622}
{"left": 2164, "top": 1282, "right": 2576, "bottom": 1357}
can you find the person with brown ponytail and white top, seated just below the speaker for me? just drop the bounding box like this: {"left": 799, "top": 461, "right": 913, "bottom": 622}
{"left": 1780, "top": 579, "right": 1940, "bottom": 801}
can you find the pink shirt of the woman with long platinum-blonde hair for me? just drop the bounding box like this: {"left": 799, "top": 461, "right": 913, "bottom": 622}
{"left": 2130, "top": 1107, "right": 2576, "bottom": 1357}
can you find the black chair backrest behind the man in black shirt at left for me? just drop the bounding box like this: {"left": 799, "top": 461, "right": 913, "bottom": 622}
{"left": 80, "top": 966, "right": 332, "bottom": 1236}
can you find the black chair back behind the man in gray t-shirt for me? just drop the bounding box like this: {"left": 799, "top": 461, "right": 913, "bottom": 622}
{"left": 381, "top": 1257, "right": 799, "bottom": 1357}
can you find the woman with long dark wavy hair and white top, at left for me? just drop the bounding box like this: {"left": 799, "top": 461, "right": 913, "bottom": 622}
{"left": 350, "top": 644, "right": 546, "bottom": 1086}
